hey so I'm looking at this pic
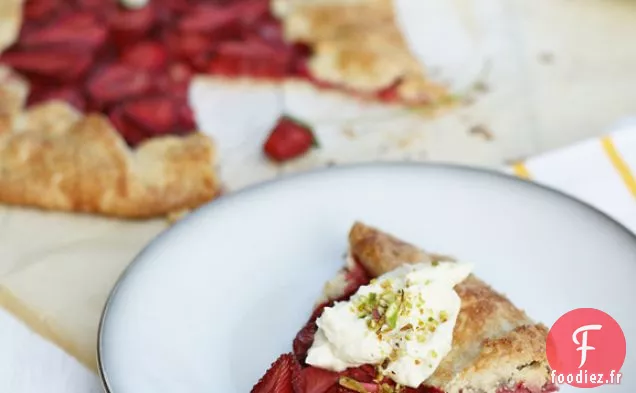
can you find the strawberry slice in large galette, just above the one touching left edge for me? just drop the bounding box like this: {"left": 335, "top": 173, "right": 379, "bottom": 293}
{"left": 20, "top": 12, "right": 108, "bottom": 50}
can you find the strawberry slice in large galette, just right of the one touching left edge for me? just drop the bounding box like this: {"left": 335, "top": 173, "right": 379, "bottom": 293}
{"left": 87, "top": 64, "right": 152, "bottom": 103}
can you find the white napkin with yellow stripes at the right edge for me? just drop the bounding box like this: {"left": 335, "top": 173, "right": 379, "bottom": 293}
{"left": 507, "top": 118, "right": 636, "bottom": 232}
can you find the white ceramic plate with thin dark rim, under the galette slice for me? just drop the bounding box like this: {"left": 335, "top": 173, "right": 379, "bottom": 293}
{"left": 99, "top": 164, "right": 636, "bottom": 393}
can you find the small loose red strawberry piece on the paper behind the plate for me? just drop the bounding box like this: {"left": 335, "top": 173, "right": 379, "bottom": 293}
{"left": 263, "top": 116, "right": 316, "bottom": 162}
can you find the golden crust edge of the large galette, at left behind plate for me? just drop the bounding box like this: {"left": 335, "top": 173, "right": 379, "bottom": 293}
{"left": 0, "top": 66, "right": 219, "bottom": 218}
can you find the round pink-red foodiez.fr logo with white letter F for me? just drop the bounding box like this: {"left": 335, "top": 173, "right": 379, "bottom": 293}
{"left": 546, "top": 308, "right": 627, "bottom": 388}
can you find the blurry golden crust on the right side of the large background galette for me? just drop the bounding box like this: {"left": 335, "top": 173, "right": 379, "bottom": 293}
{"left": 272, "top": 0, "right": 448, "bottom": 103}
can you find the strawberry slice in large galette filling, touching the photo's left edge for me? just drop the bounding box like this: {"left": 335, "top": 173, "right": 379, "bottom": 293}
{"left": 0, "top": 49, "right": 92, "bottom": 81}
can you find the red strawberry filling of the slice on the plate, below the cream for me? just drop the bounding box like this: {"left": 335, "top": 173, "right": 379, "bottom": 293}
{"left": 251, "top": 262, "right": 558, "bottom": 393}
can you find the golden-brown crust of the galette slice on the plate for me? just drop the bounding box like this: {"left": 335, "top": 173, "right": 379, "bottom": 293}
{"left": 349, "top": 223, "right": 550, "bottom": 393}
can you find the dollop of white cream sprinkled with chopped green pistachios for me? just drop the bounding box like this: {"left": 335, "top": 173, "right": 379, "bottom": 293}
{"left": 306, "top": 262, "right": 472, "bottom": 388}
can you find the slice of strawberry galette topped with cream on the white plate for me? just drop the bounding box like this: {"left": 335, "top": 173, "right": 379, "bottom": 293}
{"left": 252, "top": 223, "right": 558, "bottom": 393}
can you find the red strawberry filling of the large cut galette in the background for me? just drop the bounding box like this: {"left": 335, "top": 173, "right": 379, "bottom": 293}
{"left": 0, "top": 0, "right": 402, "bottom": 146}
